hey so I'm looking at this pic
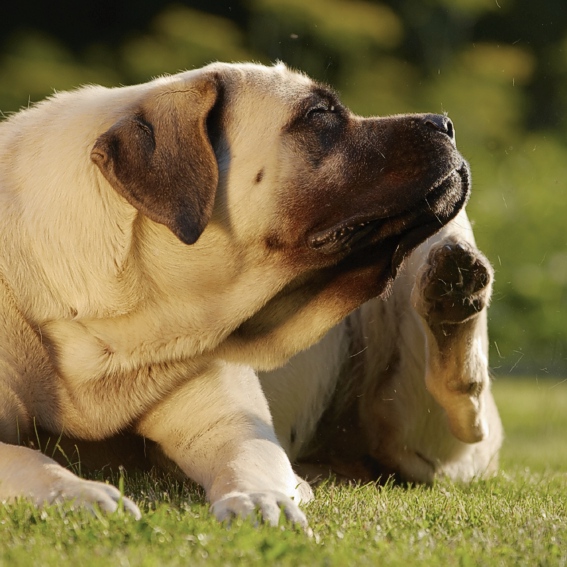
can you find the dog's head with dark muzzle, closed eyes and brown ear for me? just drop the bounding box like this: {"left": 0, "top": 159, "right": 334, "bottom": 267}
{"left": 91, "top": 64, "right": 470, "bottom": 364}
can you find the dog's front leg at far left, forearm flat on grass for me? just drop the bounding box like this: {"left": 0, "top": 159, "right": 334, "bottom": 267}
{"left": 0, "top": 280, "right": 140, "bottom": 518}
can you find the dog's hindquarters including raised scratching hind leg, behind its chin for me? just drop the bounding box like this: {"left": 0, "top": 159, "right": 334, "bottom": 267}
{"left": 260, "top": 210, "right": 502, "bottom": 482}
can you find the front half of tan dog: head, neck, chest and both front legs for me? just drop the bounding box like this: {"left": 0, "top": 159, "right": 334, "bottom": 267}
{"left": 0, "top": 60, "right": 470, "bottom": 525}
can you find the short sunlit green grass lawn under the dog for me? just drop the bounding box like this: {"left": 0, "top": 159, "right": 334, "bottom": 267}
{"left": 0, "top": 378, "right": 567, "bottom": 567}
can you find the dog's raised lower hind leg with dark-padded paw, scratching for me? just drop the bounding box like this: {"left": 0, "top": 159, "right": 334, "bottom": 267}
{"left": 412, "top": 235, "right": 499, "bottom": 443}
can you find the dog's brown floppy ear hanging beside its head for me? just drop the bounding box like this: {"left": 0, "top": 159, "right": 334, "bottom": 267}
{"left": 91, "top": 75, "right": 219, "bottom": 244}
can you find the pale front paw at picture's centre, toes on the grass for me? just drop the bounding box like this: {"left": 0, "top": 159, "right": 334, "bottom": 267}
{"left": 211, "top": 491, "right": 308, "bottom": 530}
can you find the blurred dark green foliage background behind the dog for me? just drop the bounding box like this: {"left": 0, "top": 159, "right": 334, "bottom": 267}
{"left": 0, "top": 0, "right": 567, "bottom": 377}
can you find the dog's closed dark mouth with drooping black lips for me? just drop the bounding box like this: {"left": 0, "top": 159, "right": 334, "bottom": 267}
{"left": 308, "top": 162, "right": 470, "bottom": 267}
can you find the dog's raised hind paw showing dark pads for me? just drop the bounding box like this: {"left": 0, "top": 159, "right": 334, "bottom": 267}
{"left": 412, "top": 240, "right": 493, "bottom": 325}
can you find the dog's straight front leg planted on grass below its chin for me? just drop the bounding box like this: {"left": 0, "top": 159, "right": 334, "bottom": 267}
{"left": 137, "top": 362, "right": 312, "bottom": 527}
